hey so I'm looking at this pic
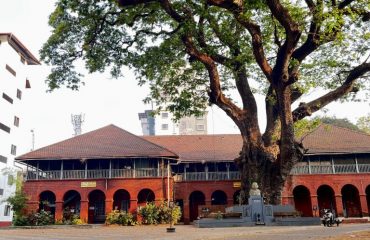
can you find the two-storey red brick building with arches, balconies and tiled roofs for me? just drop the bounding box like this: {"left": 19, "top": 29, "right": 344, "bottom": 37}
{"left": 17, "top": 125, "right": 370, "bottom": 223}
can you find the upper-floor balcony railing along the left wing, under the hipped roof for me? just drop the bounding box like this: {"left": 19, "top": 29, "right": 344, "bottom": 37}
{"left": 25, "top": 168, "right": 167, "bottom": 180}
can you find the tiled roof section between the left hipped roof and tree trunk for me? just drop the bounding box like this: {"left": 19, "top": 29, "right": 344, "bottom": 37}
{"left": 144, "top": 134, "right": 243, "bottom": 162}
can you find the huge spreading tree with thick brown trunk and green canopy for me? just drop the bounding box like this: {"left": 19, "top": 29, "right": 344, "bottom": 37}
{"left": 41, "top": 0, "right": 370, "bottom": 203}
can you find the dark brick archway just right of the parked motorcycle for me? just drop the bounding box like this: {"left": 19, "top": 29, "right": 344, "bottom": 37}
{"left": 342, "top": 184, "right": 362, "bottom": 217}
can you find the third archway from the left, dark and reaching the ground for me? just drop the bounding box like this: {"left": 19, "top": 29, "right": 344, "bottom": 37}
{"left": 88, "top": 190, "right": 105, "bottom": 223}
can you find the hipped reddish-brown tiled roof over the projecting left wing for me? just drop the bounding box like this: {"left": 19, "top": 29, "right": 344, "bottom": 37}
{"left": 16, "top": 125, "right": 178, "bottom": 160}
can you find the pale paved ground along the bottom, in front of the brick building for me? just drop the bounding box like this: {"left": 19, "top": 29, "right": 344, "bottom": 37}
{"left": 0, "top": 224, "right": 370, "bottom": 240}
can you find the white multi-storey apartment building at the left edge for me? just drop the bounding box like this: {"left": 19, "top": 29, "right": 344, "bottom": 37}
{"left": 0, "top": 33, "right": 40, "bottom": 227}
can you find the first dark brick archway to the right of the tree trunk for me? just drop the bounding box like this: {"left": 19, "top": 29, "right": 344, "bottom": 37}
{"left": 293, "top": 185, "right": 312, "bottom": 217}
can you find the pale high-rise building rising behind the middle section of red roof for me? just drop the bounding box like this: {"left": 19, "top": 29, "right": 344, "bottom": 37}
{"left": 139, "top": 110, "right": 208, "bottom": 136}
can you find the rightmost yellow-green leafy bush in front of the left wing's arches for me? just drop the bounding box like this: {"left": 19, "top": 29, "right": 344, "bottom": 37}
{"left": 138, "top": 202, "right": 181, "bottom": 224}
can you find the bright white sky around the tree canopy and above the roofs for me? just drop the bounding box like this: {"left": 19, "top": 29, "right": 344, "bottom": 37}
{"left": 0, "top": 0, "right": 370, "bottom": 155}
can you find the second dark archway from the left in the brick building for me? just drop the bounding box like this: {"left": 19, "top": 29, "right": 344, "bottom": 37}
{"left": 63, "top": 190, "right": 81, "bottom": 219}
